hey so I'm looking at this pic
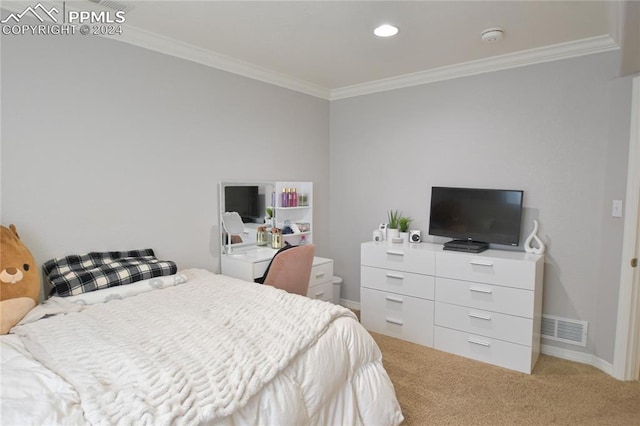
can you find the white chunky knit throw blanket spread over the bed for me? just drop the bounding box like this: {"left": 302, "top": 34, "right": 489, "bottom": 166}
{"left": 14, "top": 270, "right": 353, "bottom": 425}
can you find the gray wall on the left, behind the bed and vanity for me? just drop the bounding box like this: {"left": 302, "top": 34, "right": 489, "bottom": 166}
{"left": 1, "top": 32, "right": 329, "bottom": 271}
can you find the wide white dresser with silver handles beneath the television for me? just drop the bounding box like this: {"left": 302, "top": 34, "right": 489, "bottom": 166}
{"left": 360, "top": 242, "right": 544, "bottom": 373}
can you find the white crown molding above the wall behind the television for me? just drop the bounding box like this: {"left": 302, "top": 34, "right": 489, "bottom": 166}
{"left": 330, "top": 36, "right": 620, "bottom": 101}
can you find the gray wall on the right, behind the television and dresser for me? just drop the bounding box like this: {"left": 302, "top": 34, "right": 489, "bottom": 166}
{"left": 330, "top": 53, "right": 631, "bottom": 362}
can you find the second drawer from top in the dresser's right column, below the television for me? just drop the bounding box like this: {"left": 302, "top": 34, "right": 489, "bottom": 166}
{"left": 435, "top": 277, "right": 534, "bottom": 318}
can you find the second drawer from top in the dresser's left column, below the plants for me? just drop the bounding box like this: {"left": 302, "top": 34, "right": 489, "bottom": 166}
{"left": 360, "top": 266, "right": 435, "bottom": 300}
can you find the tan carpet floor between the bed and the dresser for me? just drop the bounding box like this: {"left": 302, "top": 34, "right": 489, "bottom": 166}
{"left": 371, "top": 333, "right": 640, "bottom": 426}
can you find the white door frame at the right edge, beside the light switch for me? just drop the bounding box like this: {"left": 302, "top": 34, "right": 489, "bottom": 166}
{"left": 613, "top": 76, "right": 640, "bottom": 380}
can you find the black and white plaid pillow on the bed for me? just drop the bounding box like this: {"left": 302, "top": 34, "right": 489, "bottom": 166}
{"left": 42, "top": 249, "right": 178, "bottom": 296}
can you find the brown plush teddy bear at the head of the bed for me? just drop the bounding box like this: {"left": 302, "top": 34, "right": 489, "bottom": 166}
{"left": 0, "top": 225, "right": 40, "bottom": 334}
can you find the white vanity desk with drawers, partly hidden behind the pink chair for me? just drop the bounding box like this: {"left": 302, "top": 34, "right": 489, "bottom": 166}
{"left": 220, "top": 246, "right": 333, "bottom": 302}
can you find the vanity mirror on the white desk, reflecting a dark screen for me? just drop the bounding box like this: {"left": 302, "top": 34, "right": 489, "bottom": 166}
{"left": 219, "top": 181, "right": 275, "bottom": 252}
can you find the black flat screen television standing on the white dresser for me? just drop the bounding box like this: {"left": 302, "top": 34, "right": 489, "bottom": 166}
{"left": 429, "top": 186, "right": 524, "bottom": 252}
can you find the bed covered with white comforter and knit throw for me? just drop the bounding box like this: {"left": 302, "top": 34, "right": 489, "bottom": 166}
{"left": 0, "top": 269, "right": 403, "bottom": 425}
